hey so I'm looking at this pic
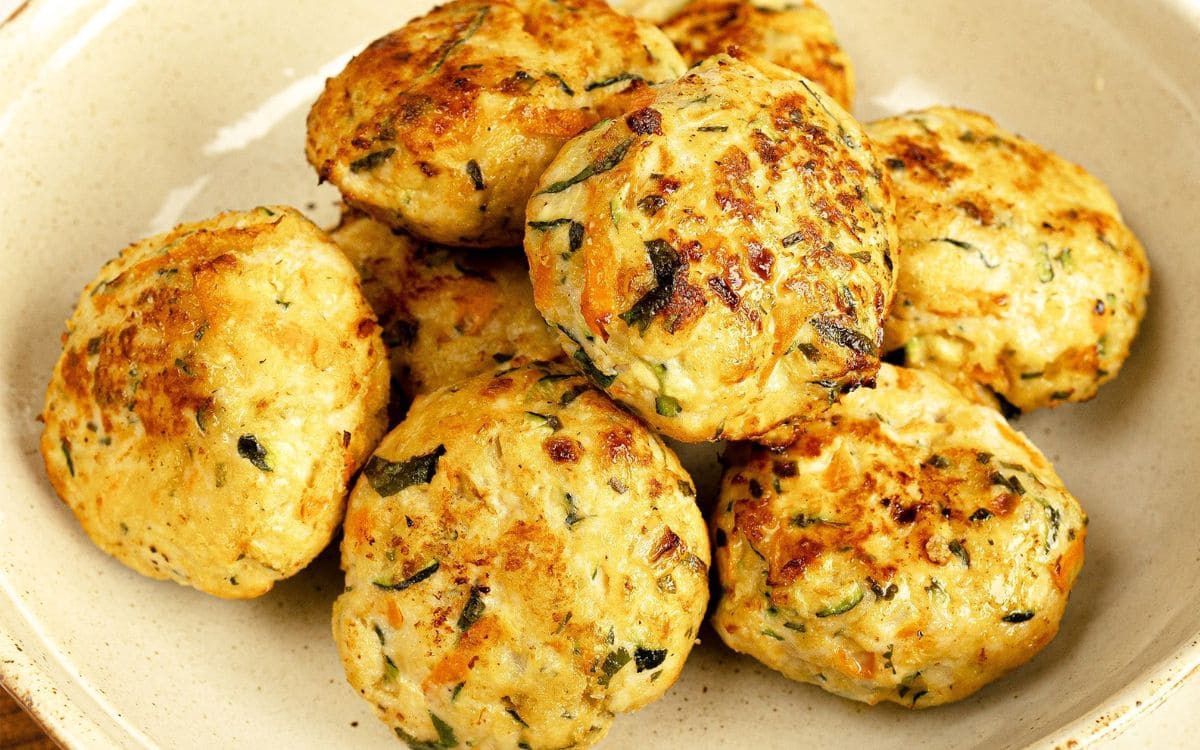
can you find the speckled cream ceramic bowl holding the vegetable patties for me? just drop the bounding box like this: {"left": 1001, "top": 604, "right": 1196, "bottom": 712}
{"left": 0, "top": 0, "right": 1200, "bottom": 750}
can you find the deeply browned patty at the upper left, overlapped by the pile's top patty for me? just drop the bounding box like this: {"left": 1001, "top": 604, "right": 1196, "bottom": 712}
{"left": 307, "top": 0, "right": 684, "bottom": 247}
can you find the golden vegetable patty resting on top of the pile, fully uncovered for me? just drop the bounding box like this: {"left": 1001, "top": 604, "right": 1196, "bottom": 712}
{"left": 526, "top": 55, "right": 895, "bottom": 442}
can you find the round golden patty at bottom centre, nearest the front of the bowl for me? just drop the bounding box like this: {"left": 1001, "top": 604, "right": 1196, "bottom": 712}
{"left": 334, "top": 365, "right": 709, "bottom": 748}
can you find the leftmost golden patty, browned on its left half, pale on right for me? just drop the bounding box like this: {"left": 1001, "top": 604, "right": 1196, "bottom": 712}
{"left": 41, "top": 206, "right": 388, "bottom": 598}
